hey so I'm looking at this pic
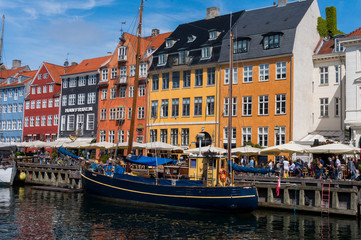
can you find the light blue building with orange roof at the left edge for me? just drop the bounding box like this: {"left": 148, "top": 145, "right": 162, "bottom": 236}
{"left": 0, "top": 71, "right": 36, "bottom": 143}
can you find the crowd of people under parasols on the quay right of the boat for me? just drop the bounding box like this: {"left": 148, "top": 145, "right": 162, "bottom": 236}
{"left": 239, "top": 156, "right": 361, "bottom": 181}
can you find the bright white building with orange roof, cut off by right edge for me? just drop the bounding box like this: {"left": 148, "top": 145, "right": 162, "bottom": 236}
{"left": 340, "top": 28, "right": 361, "bottom": 147}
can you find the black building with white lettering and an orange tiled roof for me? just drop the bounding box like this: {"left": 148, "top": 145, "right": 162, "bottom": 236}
{"left": 59, "top": 56, "right": 110, "bottom": 142}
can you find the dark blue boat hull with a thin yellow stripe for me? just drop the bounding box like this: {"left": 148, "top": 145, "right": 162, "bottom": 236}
{"left": 82, "top": 169, "right": 258, "bottom": 212}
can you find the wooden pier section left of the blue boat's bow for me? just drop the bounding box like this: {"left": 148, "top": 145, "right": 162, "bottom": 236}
{"left": 17, "top": 162, "right": 82, "bottom": 189}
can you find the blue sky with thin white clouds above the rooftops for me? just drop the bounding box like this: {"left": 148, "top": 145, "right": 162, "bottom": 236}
{"left": 0, "top": 0, "right": 361, "bottom": 70}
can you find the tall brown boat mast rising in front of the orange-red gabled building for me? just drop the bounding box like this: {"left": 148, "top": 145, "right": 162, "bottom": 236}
{"left": 126, "top": 0, "right": 143, "bottom": 172}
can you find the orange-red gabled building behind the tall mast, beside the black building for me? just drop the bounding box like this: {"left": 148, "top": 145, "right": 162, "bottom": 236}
{"left": 97, "top": 29, "right": 170, "bottom": 156}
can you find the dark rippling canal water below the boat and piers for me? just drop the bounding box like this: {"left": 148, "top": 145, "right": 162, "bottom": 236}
{"left": 0, "top": 186, "right": 361, "bottom": 240}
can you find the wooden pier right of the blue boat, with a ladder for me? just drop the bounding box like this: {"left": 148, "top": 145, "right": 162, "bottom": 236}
{"left": 235, "top": 175, "right": 361, "bottom": 216}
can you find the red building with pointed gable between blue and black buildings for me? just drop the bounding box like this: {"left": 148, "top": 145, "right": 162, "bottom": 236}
{"left": 23, "top": 62, "right": 75, "bottom": 142}
